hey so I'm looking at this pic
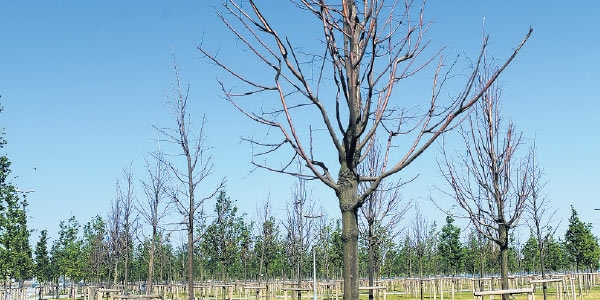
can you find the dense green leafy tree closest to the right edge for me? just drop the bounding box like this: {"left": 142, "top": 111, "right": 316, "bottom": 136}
{"left": 565, "top": 206, "right": 600, "bottom": 272}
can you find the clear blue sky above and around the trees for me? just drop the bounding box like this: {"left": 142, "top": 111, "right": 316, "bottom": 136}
{"left": 0, "top": 0, "right": 600, "bottom": 244}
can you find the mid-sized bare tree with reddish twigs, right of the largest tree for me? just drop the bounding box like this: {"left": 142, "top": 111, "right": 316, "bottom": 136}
{"left": 440, "top": 79, "right": 532, "bottom": 296}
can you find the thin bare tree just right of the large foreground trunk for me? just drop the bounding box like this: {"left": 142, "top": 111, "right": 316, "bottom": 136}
{"left": 359, "top": 141, "right": 410, "bottom": 299}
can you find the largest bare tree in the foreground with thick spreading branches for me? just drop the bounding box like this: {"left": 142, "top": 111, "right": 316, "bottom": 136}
{"left": 199, "top": 0, "right": 531, "bottom": 300}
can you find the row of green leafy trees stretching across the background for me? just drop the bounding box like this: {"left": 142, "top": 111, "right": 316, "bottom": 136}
{"left": 23, "top": 197, "right": 600, "bottom": 284}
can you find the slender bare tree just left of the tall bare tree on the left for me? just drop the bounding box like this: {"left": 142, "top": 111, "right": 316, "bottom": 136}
{"left": 137, "top": 150, "right": 171, "bottom": 293}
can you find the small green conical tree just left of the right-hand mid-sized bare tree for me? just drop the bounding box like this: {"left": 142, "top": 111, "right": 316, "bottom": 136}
{"left": 438, "top": 216, "right": 464, "bottom": 275}
